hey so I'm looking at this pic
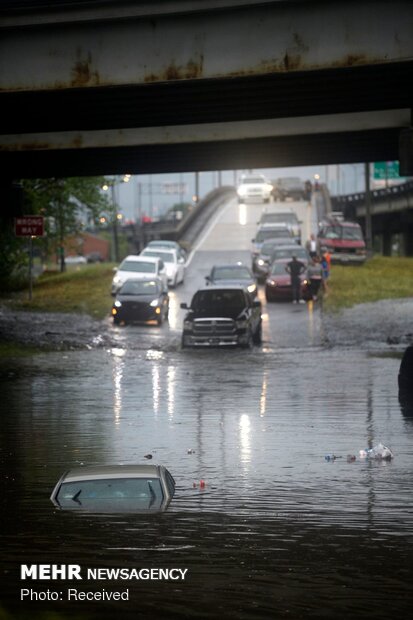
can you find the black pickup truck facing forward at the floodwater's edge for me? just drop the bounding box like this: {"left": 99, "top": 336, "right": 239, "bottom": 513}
{"left": 181, "top": 286, "right": 261, "bottom": 348}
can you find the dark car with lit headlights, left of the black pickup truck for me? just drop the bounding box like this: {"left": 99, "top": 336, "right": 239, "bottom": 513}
{"left": 112, "top": 278, "right": 169, "bottom": 325}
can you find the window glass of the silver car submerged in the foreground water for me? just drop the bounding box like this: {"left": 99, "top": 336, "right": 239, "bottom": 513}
{"left": 56, "top": 478, "right": 163, "bottom": 508}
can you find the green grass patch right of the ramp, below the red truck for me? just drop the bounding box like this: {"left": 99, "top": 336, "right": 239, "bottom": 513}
{"left": 324, "top": 256, "right": 413, "bottom": 312}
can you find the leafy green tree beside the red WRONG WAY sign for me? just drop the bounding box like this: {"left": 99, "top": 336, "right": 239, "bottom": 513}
{"left": 22, "top": 177, "right": 113, "bottom": 271}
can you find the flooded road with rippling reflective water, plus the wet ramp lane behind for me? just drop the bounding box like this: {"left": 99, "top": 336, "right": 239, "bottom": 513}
{"left": 0, "top": 197, "right": 413, "bottom": 620}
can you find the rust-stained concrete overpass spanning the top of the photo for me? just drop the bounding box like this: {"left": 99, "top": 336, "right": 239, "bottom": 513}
{"left": 0, "top": 0, "right": 413, "bottom": 179}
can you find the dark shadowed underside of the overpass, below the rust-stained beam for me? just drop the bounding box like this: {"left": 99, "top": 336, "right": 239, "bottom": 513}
{"left": 0, "top": 62, "right": 413, "bottom": 178}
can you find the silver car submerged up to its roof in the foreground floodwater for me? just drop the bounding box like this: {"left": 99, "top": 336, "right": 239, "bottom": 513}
{"left": 50, "top": 465, "right": 175, "bottom": 513}
